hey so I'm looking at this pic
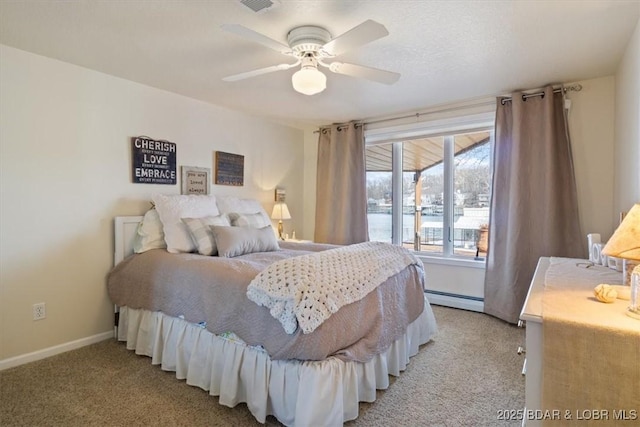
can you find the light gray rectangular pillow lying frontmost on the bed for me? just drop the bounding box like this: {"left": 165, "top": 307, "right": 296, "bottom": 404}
{"left": 211, "top": 225, "right": 280, "bottom": 258}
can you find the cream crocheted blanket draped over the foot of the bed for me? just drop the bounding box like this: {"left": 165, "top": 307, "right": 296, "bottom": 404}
{"left": 247, "top": 242, "right": 424, "bottom": 334}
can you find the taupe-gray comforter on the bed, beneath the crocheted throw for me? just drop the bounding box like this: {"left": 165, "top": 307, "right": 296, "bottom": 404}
{"left": 107, "top": 242, "right": 424, "bottom": 362}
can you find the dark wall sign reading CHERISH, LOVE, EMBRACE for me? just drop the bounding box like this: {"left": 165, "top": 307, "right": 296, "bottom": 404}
{"left": 131, "top": 136, "right": 177, "bottom": 185}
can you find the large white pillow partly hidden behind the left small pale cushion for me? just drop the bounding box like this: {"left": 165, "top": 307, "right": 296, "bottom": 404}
{"left": 153, "top": 194, "right": 219, "bottom": 253}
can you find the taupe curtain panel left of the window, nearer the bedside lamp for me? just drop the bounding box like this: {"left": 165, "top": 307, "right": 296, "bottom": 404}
{"left": 314, "top": 123, "right": 369, "bottom": 245}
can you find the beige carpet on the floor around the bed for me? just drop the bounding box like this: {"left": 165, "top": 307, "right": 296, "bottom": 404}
{"left": 0, "top": 306, "right": 524, "bottom": 427}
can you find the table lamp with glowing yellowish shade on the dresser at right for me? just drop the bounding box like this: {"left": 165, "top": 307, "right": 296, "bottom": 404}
{"left": 602, "top": 203, "right": 640, "bottom": 319}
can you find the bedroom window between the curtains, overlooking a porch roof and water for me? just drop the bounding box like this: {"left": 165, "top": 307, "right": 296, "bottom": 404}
{"left": 366, "top": 114, "right": 493, "bottom": 259}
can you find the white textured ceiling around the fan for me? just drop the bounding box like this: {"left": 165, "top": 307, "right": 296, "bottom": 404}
{"left": 0, "top": 0, "right": 640, "bottom": 126}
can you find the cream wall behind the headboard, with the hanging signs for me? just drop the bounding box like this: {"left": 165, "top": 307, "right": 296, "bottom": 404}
{"left": 0, "top": 46, "right": 304, "bottom": 365}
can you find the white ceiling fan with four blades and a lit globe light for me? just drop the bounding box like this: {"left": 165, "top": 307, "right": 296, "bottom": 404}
{"left": 222, "top": 20, "right": 400, "bottom": 95}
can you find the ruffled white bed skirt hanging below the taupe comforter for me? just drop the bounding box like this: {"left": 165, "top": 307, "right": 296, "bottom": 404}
{"left": 118, "top": 300, "right": 436, "bottom": 426}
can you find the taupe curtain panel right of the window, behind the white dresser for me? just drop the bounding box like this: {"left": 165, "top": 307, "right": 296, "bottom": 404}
{"left": 484, "top": 86, "right": 585, "bottom": 323}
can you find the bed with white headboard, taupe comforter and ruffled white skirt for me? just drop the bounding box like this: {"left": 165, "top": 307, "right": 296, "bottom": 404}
{"left": 108, "top": 195, "right": 437, "bottom": 426}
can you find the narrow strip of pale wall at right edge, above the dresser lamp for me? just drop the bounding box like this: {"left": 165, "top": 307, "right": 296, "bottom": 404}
{"left": 613, "top": 19, "right": 640, "bottom": 214}
